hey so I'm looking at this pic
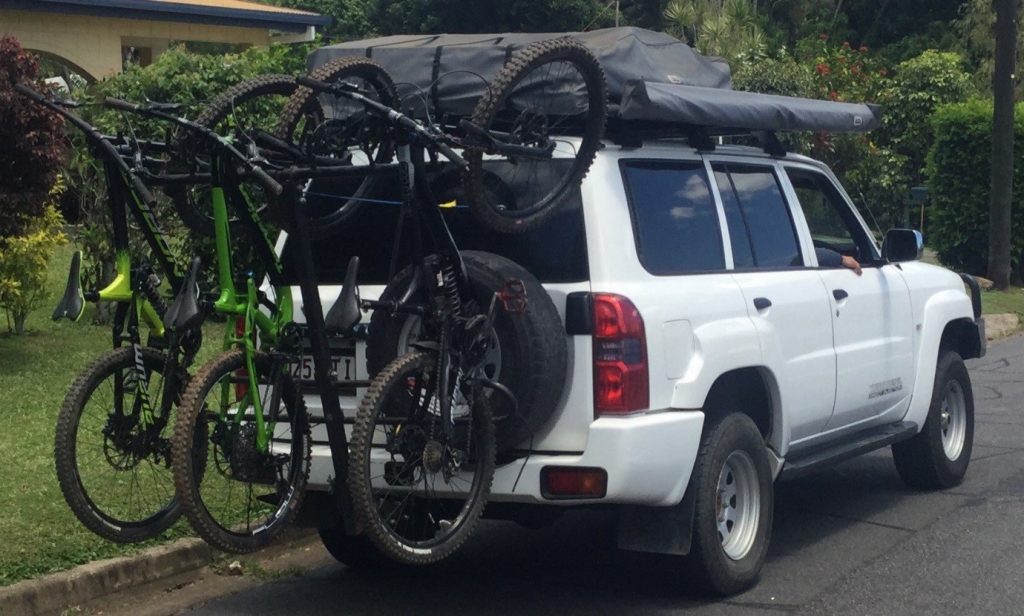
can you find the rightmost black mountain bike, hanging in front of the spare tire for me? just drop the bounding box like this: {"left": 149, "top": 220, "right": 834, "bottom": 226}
{"left": 266, "top": 40, "right": 604, "bottom": 564}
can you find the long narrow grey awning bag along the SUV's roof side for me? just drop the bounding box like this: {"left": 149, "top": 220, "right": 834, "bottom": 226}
{"left": 618, "top": 81, "right": 882, "bottom": 132}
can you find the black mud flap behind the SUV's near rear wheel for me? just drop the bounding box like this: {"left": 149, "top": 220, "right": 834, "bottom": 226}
{"left": 618, "top": 486, "right": 693, "bottom": 556}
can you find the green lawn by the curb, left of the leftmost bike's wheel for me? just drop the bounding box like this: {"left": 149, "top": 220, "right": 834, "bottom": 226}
{"left": 0, "top": 246, "right": 219, "bottom": 585}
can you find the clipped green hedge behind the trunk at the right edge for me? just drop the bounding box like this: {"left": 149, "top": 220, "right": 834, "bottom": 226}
{"left": 924, "top": 100, "right": 1024, "bottom": 277}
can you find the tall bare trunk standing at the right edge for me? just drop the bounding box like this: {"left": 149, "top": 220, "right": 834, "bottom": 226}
{"left": 988, "top": 0, "right": 1018, "bottom": 289}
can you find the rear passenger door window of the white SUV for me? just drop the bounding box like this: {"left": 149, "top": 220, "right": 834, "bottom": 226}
{"left": 712, "top": 163, "right": 804, "bottom": 269}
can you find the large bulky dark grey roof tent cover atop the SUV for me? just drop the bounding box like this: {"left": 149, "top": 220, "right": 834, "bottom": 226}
{"left": 309, "top": 28, "right": 731, "bottom": 116}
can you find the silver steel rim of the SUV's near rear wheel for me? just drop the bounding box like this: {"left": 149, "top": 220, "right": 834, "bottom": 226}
{"left": 715, "top": 451, "right": 761, "bottom": 561}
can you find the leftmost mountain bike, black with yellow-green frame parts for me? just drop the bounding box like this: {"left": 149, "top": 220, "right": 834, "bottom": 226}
{"left": 15, "top": 85, "right": 202, "bottom": 542}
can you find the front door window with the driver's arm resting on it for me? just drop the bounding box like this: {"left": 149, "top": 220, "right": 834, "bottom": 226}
{"left": 785, "top": 168, "right": 877, "bottom": 262}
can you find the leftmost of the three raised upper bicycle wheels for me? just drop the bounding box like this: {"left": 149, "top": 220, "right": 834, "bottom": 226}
{"left": 167, "top": 75, "right": 298, "bottom": 235}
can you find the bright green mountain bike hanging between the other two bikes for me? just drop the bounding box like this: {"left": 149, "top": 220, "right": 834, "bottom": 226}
{"left": 105, "top": 76, "right": 323, "bottom": 553}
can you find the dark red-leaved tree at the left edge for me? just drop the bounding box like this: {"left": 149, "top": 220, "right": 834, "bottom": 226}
{"left": 0, "top": 36, "right": 63, "bottom": 237}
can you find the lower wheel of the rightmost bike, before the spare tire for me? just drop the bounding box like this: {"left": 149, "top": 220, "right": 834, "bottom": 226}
{"left": 348, "top": 352, "right": 496, "bottom": 565}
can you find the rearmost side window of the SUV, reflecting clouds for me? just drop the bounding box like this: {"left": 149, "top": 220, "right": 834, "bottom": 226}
{"left": 621, "top": 161, "right": 725, "bottom": 275}
